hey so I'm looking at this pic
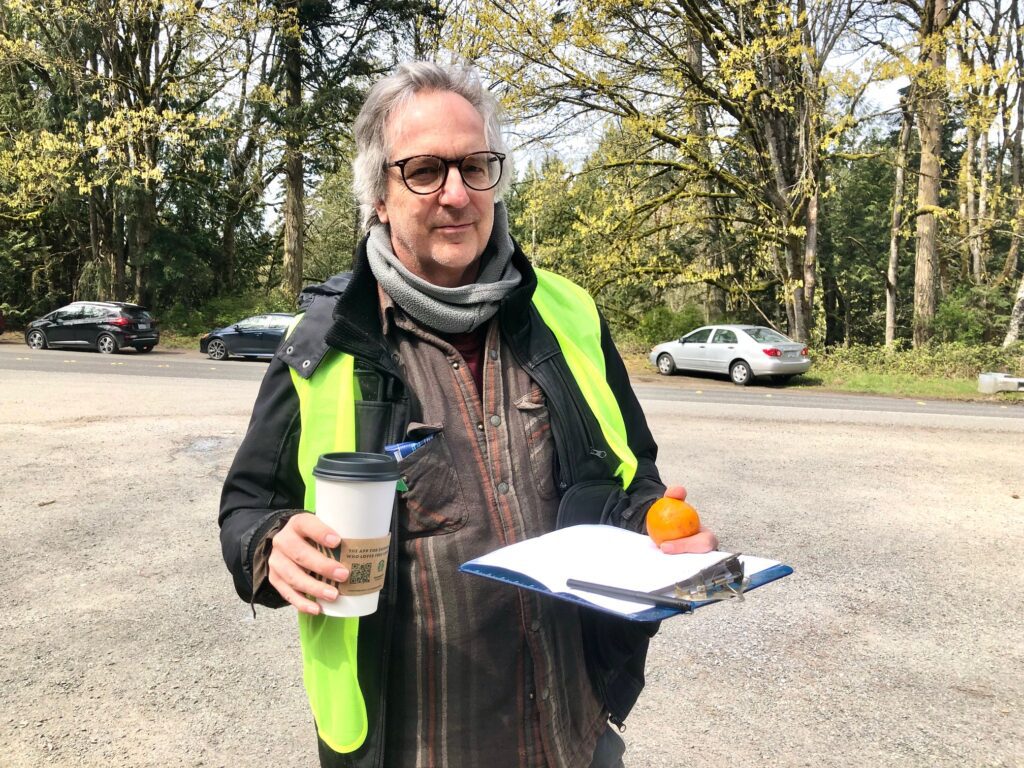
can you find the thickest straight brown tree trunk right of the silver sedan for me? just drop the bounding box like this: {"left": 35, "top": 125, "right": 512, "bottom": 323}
{"left": 913, "top": 0, "right": 946, "bottom": 347}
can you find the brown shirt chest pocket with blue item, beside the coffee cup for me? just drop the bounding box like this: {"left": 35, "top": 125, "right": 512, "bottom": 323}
{"left": 398, "top": 425, "right": 467, "bottom": 540}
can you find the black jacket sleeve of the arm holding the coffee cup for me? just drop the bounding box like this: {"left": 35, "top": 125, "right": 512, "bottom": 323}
{"left": 218, "top": 357, "right": 305, "bottom": 607}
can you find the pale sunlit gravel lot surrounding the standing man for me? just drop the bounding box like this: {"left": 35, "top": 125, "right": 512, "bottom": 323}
{"left": 0, "top": 356, "right": 1024, "bottom": 768}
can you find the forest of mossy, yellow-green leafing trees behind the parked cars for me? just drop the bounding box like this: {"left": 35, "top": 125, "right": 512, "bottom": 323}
{"left": 0, "top": 0, "right": 1024, "bottom": 387}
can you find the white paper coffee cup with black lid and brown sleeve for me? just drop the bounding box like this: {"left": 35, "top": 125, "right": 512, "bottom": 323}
{"left": 313, "top": 453, "right": 398, "bottom": 616}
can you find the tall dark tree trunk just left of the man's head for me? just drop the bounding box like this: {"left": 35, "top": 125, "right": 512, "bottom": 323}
{"left": 282, "top": 0, "right": 305, "bottom": 303}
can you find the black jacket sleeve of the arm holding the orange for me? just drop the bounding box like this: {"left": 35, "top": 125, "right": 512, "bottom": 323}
{"left": 601, "top": 317, "right": 665, "bottom": 531}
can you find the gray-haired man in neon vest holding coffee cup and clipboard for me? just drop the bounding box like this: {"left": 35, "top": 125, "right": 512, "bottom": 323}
{"left": 220, "top": 62, "right": 717, "bottom": 768}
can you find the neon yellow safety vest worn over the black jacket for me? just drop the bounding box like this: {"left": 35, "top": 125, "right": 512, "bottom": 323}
{"left": 290, "top": 269, "right": 637, "bottom": 753}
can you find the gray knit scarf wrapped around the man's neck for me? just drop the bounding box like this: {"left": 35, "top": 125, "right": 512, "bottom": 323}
{"left": 367, "top": 203, "right": 522, "bottom": 333}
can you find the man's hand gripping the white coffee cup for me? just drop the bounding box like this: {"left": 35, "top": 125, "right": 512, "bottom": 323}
{"left": 267, "top": 512, "right": 348, "bottom": 615}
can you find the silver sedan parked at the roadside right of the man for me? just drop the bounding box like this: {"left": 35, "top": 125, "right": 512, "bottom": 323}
{"left": 650, "top": 326, "right": 811, "bottom": 386}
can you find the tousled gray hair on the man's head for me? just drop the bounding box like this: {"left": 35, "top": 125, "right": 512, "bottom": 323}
{"left": 352, "top": 61, "right": 514, "bottom": 228}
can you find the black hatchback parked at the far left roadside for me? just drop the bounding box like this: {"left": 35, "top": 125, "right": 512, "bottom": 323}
{"left": 25, "top": 301, "right": 160, "bottom": 354}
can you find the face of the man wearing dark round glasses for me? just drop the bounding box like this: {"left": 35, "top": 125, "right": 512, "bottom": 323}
{"left": 375, "top": 91, "right": 495, "bottom": 287}
